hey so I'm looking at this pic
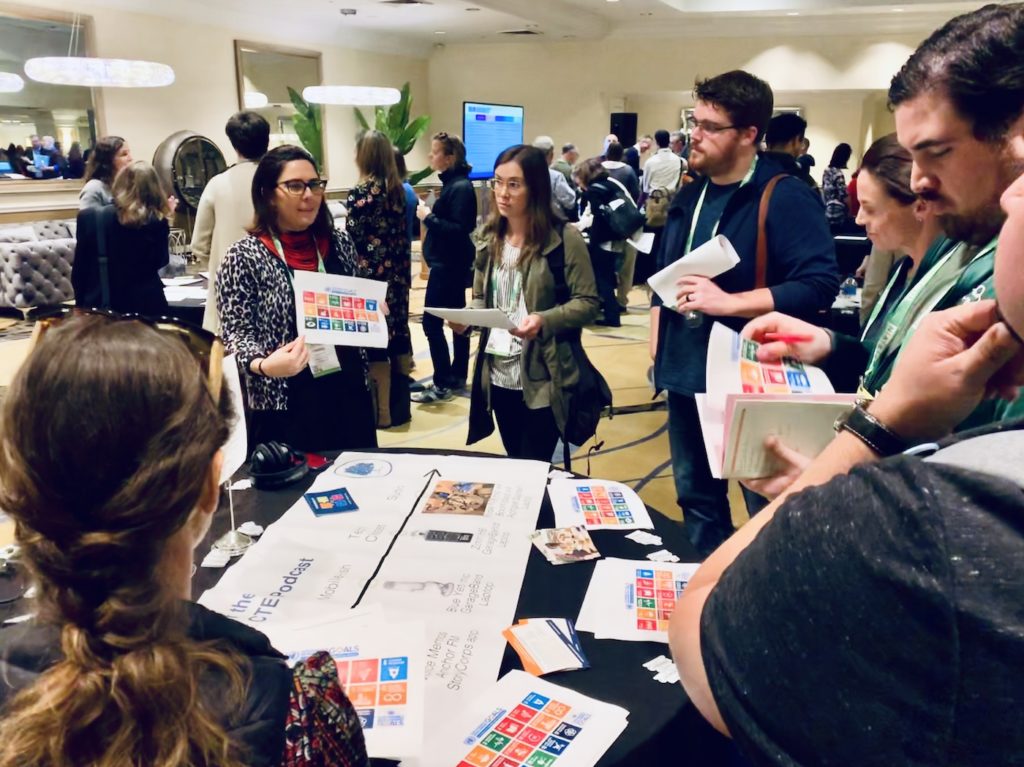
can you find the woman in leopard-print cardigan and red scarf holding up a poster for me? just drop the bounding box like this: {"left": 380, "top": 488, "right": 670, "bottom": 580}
{"left": 217, "top": 146, "right": 377, "bottom": 451}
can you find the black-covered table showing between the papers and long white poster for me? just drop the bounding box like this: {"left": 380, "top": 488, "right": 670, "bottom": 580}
{"left": 193, "top": 449, "right": 736, "bottom": 767}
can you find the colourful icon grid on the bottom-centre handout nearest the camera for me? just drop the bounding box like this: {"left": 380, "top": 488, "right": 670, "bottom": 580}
{"left": 458, "top": 692, "right": 583, "bottom": 767}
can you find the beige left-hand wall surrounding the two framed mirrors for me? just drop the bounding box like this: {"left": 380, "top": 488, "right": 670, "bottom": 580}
{"left": 7, "top": 0, "right": 429, "bottom": 187}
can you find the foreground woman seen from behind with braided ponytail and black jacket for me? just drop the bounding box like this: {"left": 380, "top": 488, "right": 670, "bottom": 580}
{"left": 0, "top": 314, "right": 365, "bottom": 767}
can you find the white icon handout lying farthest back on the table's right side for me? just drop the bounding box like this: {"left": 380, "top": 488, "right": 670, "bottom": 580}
{"left": 548, "top": 479, "right": 654, "bottom": 530}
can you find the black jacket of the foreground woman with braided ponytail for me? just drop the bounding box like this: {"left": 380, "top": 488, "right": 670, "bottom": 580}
{"left": 0, "top": 602, "right": 292, "bottom": 767}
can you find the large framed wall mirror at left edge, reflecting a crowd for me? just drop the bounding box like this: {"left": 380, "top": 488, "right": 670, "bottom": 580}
{"left": 0, "top": 5, "right": 99, "bottom": 186}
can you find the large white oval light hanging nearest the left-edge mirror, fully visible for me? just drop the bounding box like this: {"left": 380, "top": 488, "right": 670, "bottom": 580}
{"left": 25, "top": 56, "right": 174, "bottom": 88}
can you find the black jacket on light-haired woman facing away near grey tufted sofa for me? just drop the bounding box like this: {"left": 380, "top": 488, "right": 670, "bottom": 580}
{"left": 71, "top": 205, "right": 170, "bottom": 316}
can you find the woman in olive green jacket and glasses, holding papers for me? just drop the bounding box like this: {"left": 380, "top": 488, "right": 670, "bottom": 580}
{"left": 468, "top": 144, "right": 599, "bottom": 461}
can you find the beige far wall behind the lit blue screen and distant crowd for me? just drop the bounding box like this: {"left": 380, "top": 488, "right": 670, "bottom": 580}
{"left": 429, "top": 37, "right": 920, "bottom": 176}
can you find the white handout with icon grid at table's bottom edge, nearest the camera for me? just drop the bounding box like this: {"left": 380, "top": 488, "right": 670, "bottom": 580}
{"left": 417, "top": 671, "right": 629, "bottom": 767}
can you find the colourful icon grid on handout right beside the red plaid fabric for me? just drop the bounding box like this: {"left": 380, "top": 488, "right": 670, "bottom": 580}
{"left": 335, "top": 656, "right": 409, "bottom": 730}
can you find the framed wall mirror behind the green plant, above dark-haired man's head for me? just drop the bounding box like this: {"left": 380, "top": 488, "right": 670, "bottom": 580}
{"left": 234, "top": 40, "right": 327, "bottom": 172}
